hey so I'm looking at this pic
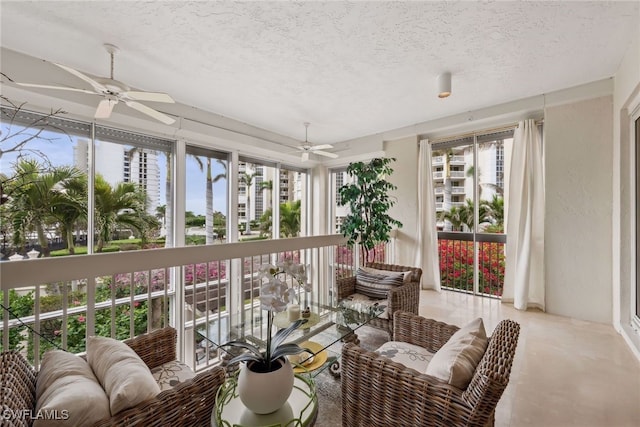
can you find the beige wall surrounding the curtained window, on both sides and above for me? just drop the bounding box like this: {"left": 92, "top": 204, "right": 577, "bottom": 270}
{"left": 384, "top": 92, "right": 613, "bottom": 323}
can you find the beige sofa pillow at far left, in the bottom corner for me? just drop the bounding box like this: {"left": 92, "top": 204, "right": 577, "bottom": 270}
{"left": 33, "top": 350, "right": 111, "bottom": 427}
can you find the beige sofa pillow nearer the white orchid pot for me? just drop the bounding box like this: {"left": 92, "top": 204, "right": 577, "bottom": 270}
{"left": 87, "top": 337, "right": 160, "bottom": 415}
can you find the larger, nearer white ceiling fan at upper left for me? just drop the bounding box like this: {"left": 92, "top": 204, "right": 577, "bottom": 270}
{"left": 14, "top": 43, "right": 175, "bottom": 125}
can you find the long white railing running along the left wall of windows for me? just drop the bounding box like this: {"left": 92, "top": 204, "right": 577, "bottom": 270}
{"left": 0, "top": 235, "right": 354, "bottom": 371}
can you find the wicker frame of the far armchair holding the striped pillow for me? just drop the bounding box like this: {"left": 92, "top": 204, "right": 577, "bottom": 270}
{"left": 336, "top": 263, "right": 422, "bottom": 337}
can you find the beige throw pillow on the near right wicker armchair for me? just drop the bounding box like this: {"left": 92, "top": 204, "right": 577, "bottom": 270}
{"left": 425, "top": 317, "right": 488, "bottom": 390}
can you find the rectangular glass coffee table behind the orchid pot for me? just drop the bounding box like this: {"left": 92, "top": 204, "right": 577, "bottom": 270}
{"left": 196, "top": 301, "right": 386, "bottom": 377}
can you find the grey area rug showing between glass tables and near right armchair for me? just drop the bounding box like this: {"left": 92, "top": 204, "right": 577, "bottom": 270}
{"left": 315, "top": 326, "right": 388, "bottom": 427}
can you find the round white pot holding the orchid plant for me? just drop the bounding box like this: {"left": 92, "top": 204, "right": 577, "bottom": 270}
{"left": 238, "top": 357, "right": 294, "bottom": 414}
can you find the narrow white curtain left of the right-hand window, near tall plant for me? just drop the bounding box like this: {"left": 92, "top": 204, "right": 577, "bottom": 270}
{"left": 416, "top": 140, "right": 440, "bottom": 291}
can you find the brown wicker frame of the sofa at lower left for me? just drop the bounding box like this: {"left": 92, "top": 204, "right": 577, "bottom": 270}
{"left": 0, "top": 327, "right": 225, "bottom": 427}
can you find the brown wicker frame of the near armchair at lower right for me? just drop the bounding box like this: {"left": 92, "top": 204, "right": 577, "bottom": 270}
{"left": 342, "top": 312, "right": 520, "bottom": 427}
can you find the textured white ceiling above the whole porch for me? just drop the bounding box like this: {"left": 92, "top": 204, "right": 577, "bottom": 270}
{"left": 0, "top": 1, "right": 640, "bottom": 143}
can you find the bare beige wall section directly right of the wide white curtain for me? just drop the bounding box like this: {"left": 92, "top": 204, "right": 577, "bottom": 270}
{"left": 544, "top": 96, "right": 613, "bottom": 323}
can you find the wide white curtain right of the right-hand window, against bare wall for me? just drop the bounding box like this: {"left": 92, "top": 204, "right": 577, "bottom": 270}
{"left": 502, "top": 120, "right": 545, "bottom": 310}
